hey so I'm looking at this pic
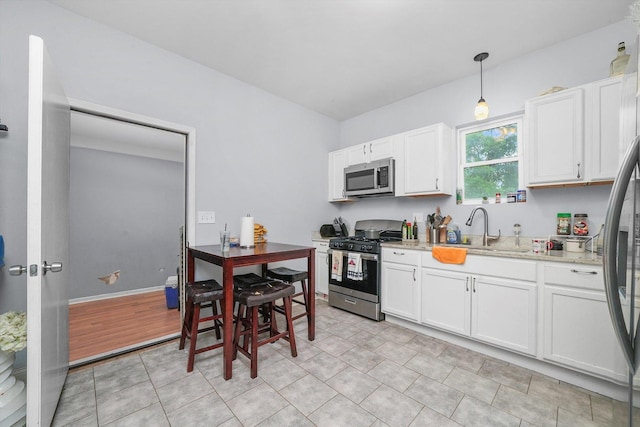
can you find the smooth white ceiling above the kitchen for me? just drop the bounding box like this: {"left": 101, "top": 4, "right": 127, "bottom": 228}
{"left": 49, "top": 0, "right": 632, "bottom": 120}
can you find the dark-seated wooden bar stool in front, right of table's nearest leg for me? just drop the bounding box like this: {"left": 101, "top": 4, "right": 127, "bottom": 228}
{"left": 233, "top": 280, "right": 298, "bottom": 378}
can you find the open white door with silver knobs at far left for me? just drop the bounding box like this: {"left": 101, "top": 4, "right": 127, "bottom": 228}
{"left": 26, "top": 36, "right": 70, "bottom": 426}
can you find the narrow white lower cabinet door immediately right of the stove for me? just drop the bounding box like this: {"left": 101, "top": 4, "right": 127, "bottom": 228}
{"left": 380, "top": 262, "right": 420, "bottom": 321}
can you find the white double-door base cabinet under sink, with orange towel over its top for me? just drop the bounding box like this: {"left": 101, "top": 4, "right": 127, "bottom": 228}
{"left": 421, "top": 252, "right": 538, "bottom": 355}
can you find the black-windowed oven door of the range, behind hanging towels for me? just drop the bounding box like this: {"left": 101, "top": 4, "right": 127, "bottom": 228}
{"left": 328, "top": 249, "right": 380, "bottom": 302}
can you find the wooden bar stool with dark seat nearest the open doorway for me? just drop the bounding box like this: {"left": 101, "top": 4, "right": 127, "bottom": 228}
{"left": 178, "top": 280, "right": 224, "bottom": 372}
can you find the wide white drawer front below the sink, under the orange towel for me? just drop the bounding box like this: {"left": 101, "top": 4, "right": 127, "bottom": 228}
{"left": 422, "top": 251, "right": 537, "bottom": 282}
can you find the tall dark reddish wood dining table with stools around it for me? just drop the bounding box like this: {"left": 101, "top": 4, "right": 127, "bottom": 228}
{"left": 187, "top": 242, "right": 316, "bottom": 380}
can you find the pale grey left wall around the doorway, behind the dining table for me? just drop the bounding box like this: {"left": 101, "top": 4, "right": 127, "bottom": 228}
{"left": 0, "top": 0, "right": 339, "bottom": 367}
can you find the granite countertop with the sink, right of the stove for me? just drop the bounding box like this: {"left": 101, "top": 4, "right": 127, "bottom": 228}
{"left": 382, "top": 241, "right": 602, "bottom": 265}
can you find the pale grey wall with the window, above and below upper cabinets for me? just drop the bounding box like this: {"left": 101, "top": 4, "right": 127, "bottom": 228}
{"left": 340, "top": 21, "right": 636, "bottom": 237}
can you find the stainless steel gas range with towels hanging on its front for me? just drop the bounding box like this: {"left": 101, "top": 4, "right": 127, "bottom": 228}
{"left": 328, "top": 219, "right": 402, "bottom": 320}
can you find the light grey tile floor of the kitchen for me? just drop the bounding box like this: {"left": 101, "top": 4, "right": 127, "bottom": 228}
{"left": 53, "top": 301, "right": 640, "bottom": 427}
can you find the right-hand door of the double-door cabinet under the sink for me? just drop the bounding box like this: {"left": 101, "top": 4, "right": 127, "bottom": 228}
{"left": 471, "top": 276, "right": 537, "bottom": 355}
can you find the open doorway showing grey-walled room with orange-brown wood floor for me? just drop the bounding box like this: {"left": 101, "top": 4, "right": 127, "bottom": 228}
{"left": 69, "top": 100, "right": 195, "bottom": 366}
